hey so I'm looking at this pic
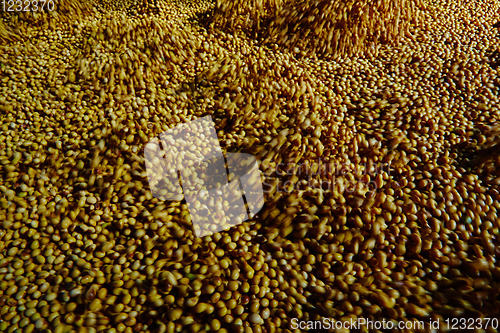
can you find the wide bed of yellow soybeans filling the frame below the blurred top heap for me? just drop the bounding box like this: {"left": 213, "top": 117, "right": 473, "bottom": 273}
{"left": 0, "top": 0, "right": 500, "bottom": 333}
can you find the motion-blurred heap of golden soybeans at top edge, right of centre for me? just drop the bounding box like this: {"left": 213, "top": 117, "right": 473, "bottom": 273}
{"left": 266, "top": 0, "right": 421, "bottom": 57}
